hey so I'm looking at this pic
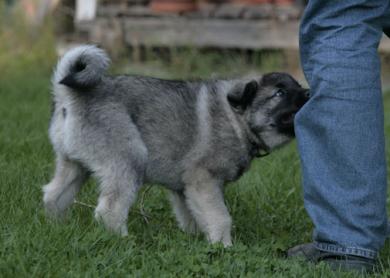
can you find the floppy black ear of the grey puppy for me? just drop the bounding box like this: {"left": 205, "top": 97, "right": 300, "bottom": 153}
{"left": 227, "top": 80, "right": 259, "bottom": 111}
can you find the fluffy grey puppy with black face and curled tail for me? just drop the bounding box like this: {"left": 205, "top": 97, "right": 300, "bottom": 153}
{"left": 43, "top": 45, "right": 307, "bottom": 246}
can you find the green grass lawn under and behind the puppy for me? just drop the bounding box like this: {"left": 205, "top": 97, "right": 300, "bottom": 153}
{"left": 0, "top": 43, "right": 390, "bottom": 277}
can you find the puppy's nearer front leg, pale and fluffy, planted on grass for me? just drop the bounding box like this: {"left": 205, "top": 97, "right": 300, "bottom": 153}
{"left": 184, "top": 170, "right": 232, "bottom": 247}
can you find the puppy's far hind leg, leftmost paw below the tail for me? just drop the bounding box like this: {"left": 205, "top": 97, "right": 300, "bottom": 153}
{"left": 43, "top": 156, "right": 87, "bottom": 217}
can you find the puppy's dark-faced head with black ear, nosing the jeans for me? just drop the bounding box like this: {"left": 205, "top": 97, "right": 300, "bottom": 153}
{"left": 228, "top": 73, "right": 309, "bottom": 149}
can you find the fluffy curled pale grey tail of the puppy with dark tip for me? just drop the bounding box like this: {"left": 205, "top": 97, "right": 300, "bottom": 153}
{"left": 52, "top": 45, "right": 110, "bottom": 89}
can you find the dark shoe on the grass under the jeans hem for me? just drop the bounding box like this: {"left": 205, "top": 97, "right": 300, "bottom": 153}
{"left": 286, "top": 243, "right": 375, "bottom": 273}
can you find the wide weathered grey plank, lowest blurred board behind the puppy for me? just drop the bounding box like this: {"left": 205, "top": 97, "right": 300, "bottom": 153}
{"left": 79, "top": 17, "right": 390, "bottom": 52}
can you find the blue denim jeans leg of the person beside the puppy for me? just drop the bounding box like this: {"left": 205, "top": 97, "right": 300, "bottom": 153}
{"left": 296, "top": 0, "right": 390, "bottom": 258}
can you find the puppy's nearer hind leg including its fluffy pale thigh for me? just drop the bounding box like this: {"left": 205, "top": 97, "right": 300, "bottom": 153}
{"left": 89, "top": 119, "right": 147, "bottom": 236}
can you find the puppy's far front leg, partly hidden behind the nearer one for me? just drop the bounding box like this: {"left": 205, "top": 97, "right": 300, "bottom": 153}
{"left": 169, "top": 191, "right": 198, "bottom": 234}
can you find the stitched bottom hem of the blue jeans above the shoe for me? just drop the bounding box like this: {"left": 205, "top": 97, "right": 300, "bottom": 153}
{"left": 314, "top": 242, "right": 378, "bottom": 260}
